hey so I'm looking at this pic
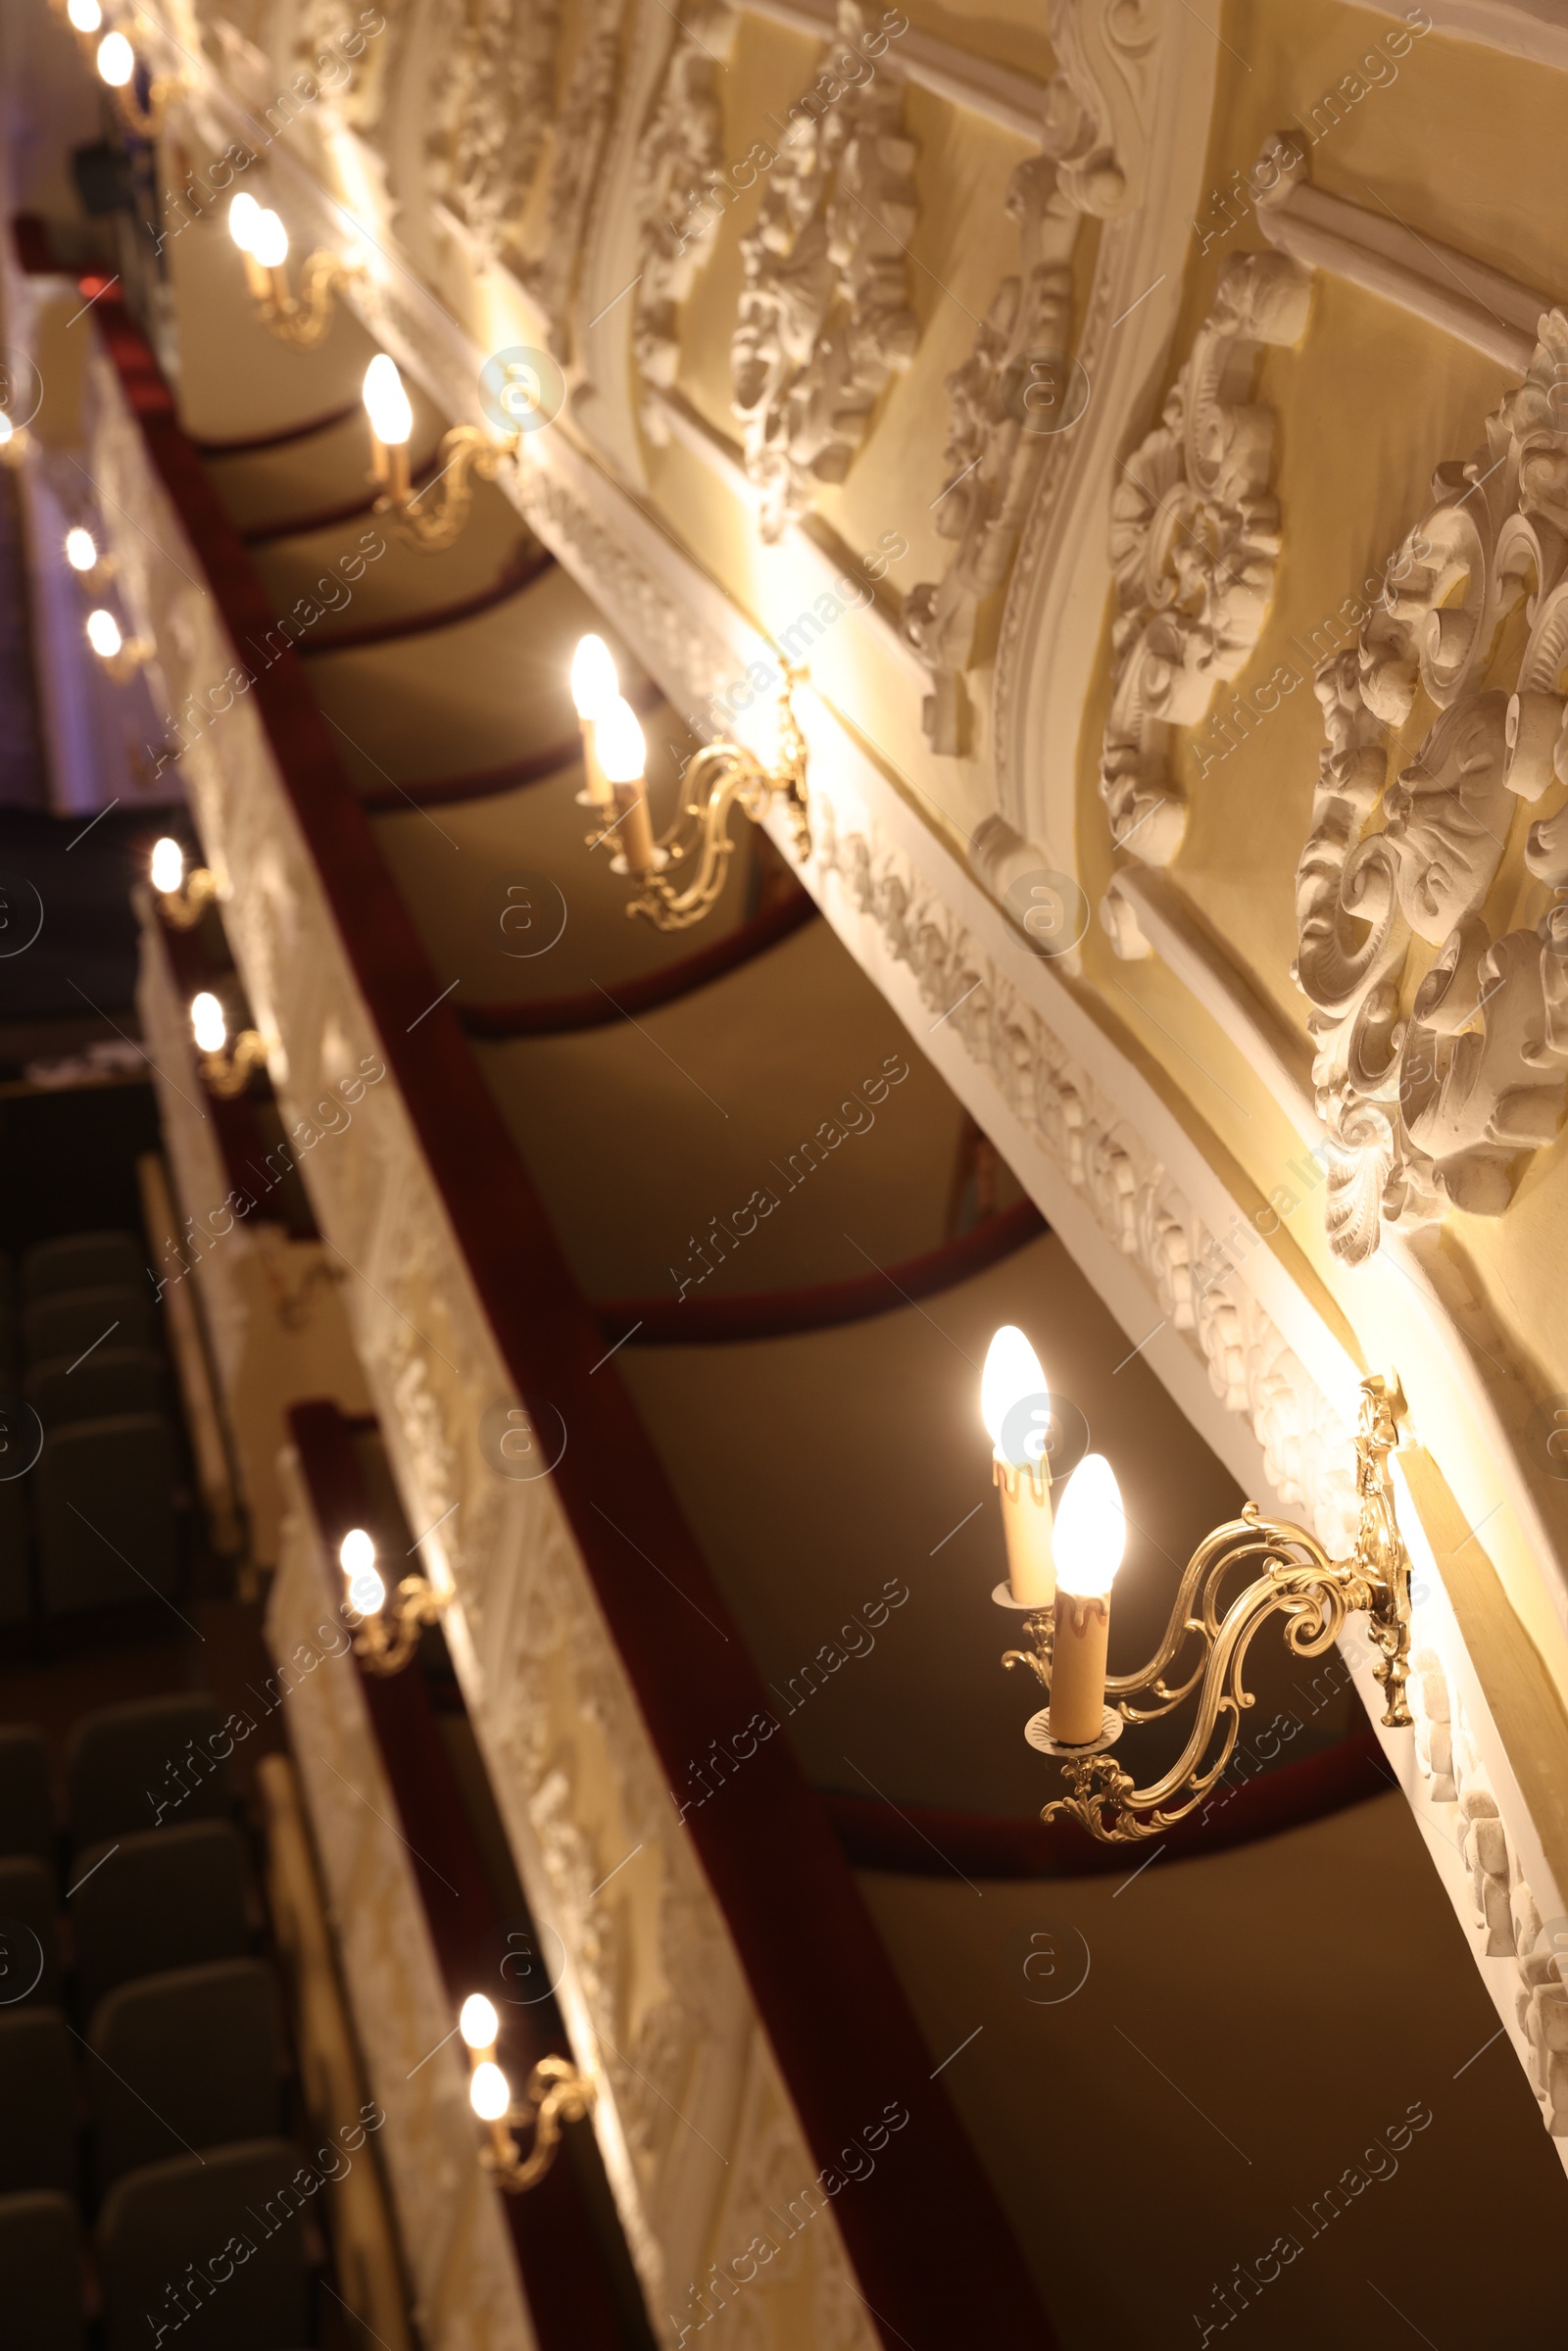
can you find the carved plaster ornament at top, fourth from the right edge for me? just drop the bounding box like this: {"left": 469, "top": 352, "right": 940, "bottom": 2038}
{"left": 731, "top": 0, "right": 919, "bottom": 541}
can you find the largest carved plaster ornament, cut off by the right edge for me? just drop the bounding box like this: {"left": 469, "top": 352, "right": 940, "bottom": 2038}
{"left": 1296, "top": 311, "right": 1568, "bottom": 1265}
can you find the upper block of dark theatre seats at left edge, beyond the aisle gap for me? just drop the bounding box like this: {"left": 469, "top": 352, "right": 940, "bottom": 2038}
{"left": 0, "top": 1232, "right": 183, "bottom": 1625}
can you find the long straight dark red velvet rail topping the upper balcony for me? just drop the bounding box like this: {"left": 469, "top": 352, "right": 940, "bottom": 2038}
{"left": 98, "top": 282, "right": 1055, "bottom": 2351}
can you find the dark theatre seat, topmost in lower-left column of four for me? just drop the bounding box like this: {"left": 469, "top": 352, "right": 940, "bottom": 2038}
{"left": 66, "top": 1690, "right": 235, "bottom": 1848}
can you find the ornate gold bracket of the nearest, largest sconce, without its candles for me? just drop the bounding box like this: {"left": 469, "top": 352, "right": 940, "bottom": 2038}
{"left": 1002, "top": 1380, "right": 1410, "bottom": 1843}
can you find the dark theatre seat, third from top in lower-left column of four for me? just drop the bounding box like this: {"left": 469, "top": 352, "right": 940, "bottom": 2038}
{"left": 88, "top": 1958, "right": 282, "bottom": 2193}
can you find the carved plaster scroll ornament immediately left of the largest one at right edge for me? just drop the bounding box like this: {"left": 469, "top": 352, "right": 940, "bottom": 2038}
{"left": 1101, "top": 254, "right": 1312, "bottom": 865}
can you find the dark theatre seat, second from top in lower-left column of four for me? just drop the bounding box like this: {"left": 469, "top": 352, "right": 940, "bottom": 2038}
{"left": 71, "top": 1820, "right": 249, "bottom": 2017}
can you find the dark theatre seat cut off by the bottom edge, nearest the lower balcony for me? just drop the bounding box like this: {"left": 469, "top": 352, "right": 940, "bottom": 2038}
{"left": 99, "top": 2139, "right": 313, "bottom": 2351}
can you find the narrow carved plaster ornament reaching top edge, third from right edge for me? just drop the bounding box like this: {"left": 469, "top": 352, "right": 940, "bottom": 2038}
{"left": 903, "top": 0, "right": 1156, "bottom": 757}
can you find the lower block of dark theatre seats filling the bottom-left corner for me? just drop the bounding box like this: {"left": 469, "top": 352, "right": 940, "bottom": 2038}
{"left": 0, "top": 1692, "right": 319, "bottom": 2351}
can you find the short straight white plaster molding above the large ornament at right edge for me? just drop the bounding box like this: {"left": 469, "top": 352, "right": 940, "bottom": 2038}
{"left": 1257, "top": 134, "right": 1549, "bottom": 376}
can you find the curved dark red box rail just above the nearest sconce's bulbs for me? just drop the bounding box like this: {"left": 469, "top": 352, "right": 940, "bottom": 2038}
{"left": 597, "top": 1199, "right": 1049, "bottom": 1347}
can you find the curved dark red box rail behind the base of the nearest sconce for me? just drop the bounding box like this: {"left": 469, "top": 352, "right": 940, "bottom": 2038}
{"left": 823, "top": 1731, "right": 1390, "bottom": 1879}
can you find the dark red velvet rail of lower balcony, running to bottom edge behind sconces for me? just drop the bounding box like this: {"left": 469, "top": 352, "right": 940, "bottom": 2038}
{"left": 289, "top": 1403, "right": 625, "bottom": 2351}
